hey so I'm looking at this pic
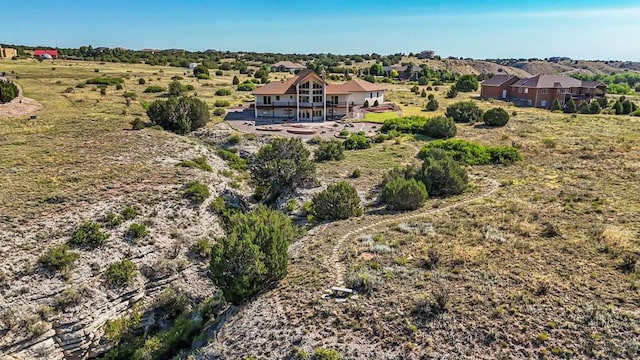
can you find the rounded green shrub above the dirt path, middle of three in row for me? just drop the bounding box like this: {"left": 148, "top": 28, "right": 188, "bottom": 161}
{"left": 382, "top": 177, "right": 427, "bottom": 210}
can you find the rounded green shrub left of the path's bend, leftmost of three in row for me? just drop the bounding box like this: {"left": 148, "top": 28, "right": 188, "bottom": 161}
{"left": 311, "top": 181, "right": 362, "bottom": 220}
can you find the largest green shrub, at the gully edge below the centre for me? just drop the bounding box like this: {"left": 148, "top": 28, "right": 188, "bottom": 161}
{"left": 210, "top": 205, "right": 301, "bottom": 304}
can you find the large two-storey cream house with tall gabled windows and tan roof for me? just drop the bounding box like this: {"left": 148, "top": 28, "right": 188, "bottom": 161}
{"left": 253, "top": 69, "right": 384, "bottom": 121}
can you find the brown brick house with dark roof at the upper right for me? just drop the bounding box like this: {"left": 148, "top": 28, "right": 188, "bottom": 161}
{"left": 480, "top": 75, "right": 607, "bottom": 109}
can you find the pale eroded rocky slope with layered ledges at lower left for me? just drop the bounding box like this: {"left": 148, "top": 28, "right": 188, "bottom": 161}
{"left": 0, "top": 149, "right": 240, "bottom": 359}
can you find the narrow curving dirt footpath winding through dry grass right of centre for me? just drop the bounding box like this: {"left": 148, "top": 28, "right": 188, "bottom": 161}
{"left": 329, "top": 179, "right": 500, "bottom": 287}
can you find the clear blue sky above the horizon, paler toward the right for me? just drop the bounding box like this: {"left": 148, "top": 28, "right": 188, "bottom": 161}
{"left": 0, "top": 0, "right": 640, "bottom": 61}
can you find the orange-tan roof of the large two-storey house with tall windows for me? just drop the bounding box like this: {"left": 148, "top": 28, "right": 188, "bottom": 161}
{"left": 253, "top": 69, "right": 384, "bottom": 95}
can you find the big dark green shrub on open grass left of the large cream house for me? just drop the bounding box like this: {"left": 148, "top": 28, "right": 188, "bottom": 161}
{"left": 147, "top": 96, "right": 210, "bottom": 134}
